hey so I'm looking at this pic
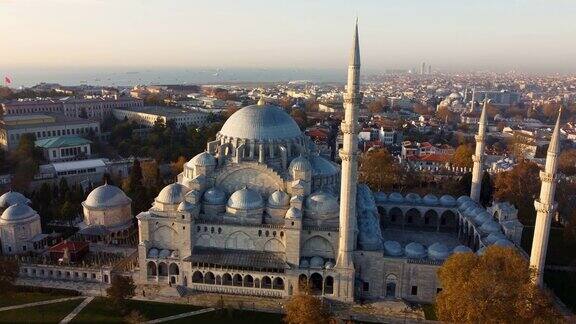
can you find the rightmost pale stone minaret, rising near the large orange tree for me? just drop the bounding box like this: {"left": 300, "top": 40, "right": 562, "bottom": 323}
{"left": 530, "top": 111, "right": 562, "bottom": 286}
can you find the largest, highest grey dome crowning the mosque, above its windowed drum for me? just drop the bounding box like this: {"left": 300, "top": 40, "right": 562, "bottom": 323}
{"left": 220, "top": 103, "right": 302, "bottom": 141}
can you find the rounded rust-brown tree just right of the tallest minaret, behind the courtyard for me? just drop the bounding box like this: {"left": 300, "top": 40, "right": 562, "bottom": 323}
{"left": 359, "top": 149, "right": 401, "bottom": 191}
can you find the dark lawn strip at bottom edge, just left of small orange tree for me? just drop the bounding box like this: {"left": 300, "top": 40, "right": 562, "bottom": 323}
{"left": 166, "top": 309, "right": 282, "bottom": 324}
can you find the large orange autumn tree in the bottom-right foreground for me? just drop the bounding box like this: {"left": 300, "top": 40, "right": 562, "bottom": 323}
{"left": 436, "top": 246, "right": 560, "bottom": 323}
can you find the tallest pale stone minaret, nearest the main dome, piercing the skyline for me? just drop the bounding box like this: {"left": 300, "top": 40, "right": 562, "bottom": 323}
{"left": 336, "top": 20, "right": 362, "bottom": 301}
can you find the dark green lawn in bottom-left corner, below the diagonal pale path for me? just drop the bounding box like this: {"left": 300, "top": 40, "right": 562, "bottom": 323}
{"left": 0, "top": 299, "right": 82, "bottom": 324}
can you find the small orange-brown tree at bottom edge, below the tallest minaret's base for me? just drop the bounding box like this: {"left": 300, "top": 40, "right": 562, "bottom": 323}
{"left": 284, "top": 293, "right": 334, "bottom": 324}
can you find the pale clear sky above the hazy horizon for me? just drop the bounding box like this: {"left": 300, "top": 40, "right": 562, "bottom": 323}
{"left": 0, "top": 0, "right": 576, "bottom": 72}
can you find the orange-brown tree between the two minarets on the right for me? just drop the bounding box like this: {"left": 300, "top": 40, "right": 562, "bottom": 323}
{"left": 494, "top": 160, "right": 540, "bottom": 224}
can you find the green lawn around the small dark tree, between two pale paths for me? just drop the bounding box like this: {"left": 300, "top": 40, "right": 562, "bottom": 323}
{"left": 72, "top": 298, "right": 203, "bottom": 323}
